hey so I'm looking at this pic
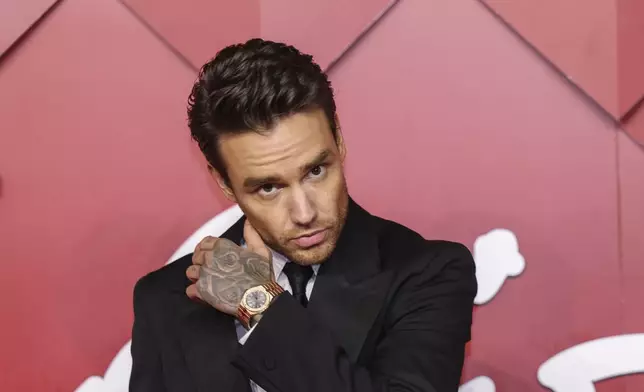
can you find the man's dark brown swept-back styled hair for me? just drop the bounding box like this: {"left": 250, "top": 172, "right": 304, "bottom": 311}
{"left": 188, "top": 38, "right": 337, "bottom": 182}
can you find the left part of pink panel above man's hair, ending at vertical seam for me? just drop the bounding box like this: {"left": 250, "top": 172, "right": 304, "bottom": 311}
{"left": 121, "top": 0, "right": 259, "bottom": 68}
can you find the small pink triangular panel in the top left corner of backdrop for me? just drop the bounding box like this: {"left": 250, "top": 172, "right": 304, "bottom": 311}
{"left": 0, "top": 0, "right": 58, "bottom": 56}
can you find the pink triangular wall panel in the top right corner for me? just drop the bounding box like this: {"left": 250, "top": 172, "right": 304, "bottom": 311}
{"left": 481, "top": 0, "right": 644, "bottom": 121}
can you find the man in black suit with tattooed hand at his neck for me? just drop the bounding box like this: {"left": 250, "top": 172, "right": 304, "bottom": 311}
{"left": 130, "top": 39, "right": 477, "bottom": 392}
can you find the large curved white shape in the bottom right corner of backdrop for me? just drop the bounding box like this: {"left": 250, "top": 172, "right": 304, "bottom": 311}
{"left": 537, "top": 333, "right": 644, "bottom": 392}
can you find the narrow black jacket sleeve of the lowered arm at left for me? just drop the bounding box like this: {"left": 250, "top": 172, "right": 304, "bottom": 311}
{"left": 129, "top": 278, "right": 165, "bottom": 392}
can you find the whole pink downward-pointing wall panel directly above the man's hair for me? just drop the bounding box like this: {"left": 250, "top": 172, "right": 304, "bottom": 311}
{"left": 121, "top": 0, "right": 398, "bottom": 69}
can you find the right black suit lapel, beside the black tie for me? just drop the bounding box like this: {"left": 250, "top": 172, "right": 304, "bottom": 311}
{"left": 308, "top": 200, "right": 393, "bottom": 363}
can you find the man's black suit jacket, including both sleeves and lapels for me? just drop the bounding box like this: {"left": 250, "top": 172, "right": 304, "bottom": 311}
{"left": 130, "top": 201, "right": 477, "bottom": 392}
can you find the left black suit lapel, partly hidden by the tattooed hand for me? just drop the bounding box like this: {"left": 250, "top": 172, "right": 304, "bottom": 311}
{"left": 178, "top": 218, "right": 250, "bottom": 392}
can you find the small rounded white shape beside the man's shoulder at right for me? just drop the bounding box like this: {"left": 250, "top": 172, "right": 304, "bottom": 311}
{"left": 473, "top": 229, "right": 525, "bottom": 305}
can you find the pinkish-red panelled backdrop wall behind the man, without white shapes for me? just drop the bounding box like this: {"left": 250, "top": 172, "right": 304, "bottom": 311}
{"left": 0, "top": 0, "right": 644, "bottom": 392}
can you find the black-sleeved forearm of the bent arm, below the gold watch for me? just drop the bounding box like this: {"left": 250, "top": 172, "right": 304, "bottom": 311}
{"left": 235, "top": 296, "right": 433, "bottom": 392}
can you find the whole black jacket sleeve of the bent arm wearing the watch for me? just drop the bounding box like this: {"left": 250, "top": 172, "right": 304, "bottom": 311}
{"left": 236, "top": 245, "right": 477, "bottom": 392}
